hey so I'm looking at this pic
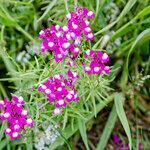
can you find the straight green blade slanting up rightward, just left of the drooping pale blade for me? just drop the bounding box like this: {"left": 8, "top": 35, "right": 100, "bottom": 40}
{"left": 96, "top": 105, "right": 117, "bottom": 150}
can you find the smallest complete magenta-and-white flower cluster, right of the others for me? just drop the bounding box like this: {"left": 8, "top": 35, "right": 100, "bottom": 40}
{"left": 83, "top": 50, "right": 110, "bottom": 74}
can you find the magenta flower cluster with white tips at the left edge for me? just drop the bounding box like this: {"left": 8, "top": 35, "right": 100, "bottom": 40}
{"left": 0, "top": 96, "right": 34, "bottom": 139}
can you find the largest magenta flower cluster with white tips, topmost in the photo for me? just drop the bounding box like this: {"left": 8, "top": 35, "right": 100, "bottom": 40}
{"left": 39, "top": 7, "right": 94, "bottom": 62}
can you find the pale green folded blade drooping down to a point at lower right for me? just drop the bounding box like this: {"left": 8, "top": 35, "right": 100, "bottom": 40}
{"left": 115, "top": 93, "right": 132, "bottom": 150}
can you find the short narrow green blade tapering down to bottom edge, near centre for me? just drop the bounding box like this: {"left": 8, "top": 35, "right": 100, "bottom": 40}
{"left": 78, "top": 119, "right": 90, "bottom": 150}
